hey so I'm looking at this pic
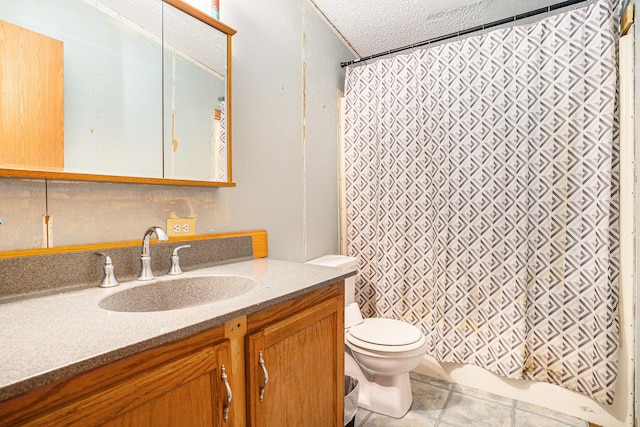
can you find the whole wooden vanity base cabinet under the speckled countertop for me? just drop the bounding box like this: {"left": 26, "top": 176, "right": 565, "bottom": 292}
{"left": 0, "top": 282, "right": 344, "bottom": 427}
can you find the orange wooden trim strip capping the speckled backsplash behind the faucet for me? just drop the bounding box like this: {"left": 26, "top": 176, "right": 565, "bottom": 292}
{"left": 0, "top": 230, "right": 269, "bottom": 259}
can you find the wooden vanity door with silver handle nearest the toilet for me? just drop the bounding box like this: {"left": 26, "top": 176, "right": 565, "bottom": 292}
{"left": 245, "top": 297, "right": 344, "bottom": 427}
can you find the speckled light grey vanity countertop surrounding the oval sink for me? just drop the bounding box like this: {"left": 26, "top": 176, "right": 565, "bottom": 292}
{"left": 0, "top": 258, "right": 355, "bottom": 401}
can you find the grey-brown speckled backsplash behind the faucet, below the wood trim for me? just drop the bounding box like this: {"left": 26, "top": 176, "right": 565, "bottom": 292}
{"left": 0, "top": 236, "right": 253, "bottom": 303}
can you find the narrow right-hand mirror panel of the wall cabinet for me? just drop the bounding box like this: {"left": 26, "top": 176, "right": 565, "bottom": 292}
{"left": 162, "top": 3, "right": 227, "bottom": 181}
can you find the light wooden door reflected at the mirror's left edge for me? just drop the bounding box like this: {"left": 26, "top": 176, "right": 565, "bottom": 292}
{"left": 0, "top": 21, "right": 64, "bottom": 170}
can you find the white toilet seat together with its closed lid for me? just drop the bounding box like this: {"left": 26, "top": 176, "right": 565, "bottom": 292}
{"left": 345, "top": 318, "right": 426, "bottom": 353}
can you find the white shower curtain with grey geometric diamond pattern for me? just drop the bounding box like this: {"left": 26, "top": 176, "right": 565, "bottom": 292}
{"left": 345, "top": 0, "right": 619, "bottom": 403}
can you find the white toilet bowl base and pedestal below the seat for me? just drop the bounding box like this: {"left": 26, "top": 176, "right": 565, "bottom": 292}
{"left": 345, "top": 353, "right": 413, "bottom": 418}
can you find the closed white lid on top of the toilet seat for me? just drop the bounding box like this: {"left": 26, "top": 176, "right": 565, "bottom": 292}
{"left": 349, "top": 317, "right": 422, "bottom": 346}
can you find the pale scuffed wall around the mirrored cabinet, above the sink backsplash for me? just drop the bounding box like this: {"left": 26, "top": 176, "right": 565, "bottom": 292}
{"left": 0, "top": 0, "right": 353, "bottom": 261}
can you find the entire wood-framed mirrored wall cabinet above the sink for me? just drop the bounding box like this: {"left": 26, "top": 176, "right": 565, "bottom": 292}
{"left": 0, "top": 0, "right": 235, "bottom": 186}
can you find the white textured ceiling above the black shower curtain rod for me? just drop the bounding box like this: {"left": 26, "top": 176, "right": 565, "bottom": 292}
{"left": 310, "top": 0, "right": 559, "bottom": 59}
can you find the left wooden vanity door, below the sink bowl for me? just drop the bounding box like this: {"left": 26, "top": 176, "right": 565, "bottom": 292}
{"left": 26, "top": 343, "right": 233, "bottom": 427}
